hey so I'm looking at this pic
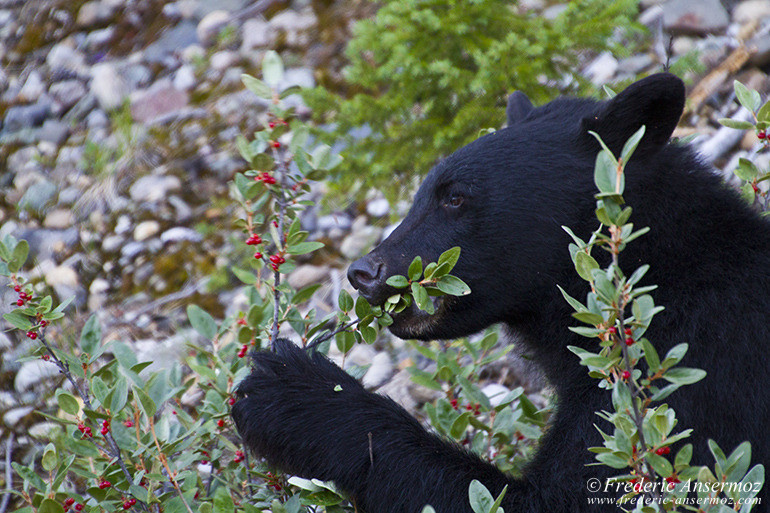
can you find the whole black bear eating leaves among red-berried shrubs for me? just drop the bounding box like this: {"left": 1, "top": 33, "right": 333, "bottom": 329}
{"left": 233, "top": 74, "right": 770, "bottom": 513}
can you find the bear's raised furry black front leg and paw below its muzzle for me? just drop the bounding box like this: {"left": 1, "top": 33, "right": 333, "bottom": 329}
{"left": 233, "top": 340, "right": 516, "bottom": 513}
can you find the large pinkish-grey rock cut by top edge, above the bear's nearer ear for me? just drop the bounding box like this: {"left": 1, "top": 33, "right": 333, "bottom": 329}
{"left": 663, "top": 0, "right": 730, "bottom": 35}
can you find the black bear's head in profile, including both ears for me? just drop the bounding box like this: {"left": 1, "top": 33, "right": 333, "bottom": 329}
{"left": 348, "top": 73, "right": 684, "bottom": 339}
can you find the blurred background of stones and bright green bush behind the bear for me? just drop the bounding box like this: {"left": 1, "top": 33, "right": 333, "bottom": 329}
{"left": 0, "top": 0, "right": 770, "bottom": 504}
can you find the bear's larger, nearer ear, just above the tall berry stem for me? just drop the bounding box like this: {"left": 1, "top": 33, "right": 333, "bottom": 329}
{"left": 581, "top": 73, "right": 685, "bottom": 155}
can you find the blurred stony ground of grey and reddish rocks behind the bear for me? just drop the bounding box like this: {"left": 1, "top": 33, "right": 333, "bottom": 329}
{"left": 0, "top": 0, "right": 770, "bottom": 478}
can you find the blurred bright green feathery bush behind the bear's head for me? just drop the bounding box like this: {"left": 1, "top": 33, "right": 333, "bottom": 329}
{"left": 305, "top": 0, "right": 637, "bottom": 197}
